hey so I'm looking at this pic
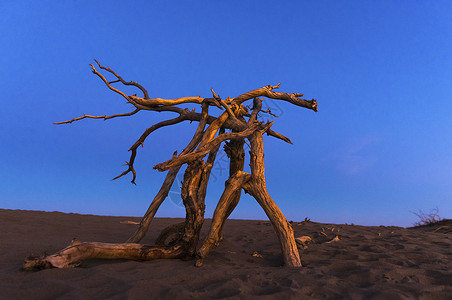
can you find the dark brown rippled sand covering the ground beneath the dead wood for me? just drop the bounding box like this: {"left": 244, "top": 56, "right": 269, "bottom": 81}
{"left": 0, "top": 209, "right": 452, "bottom": 299}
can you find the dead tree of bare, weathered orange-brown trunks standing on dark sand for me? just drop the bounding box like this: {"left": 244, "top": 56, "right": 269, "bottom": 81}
{"left": 24, "top": 60, "right": 317, "bottom": 270}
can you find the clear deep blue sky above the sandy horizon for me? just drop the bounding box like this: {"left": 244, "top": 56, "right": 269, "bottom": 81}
{"left": 0, "top": 0, "right": 452, "bottom": 226}
